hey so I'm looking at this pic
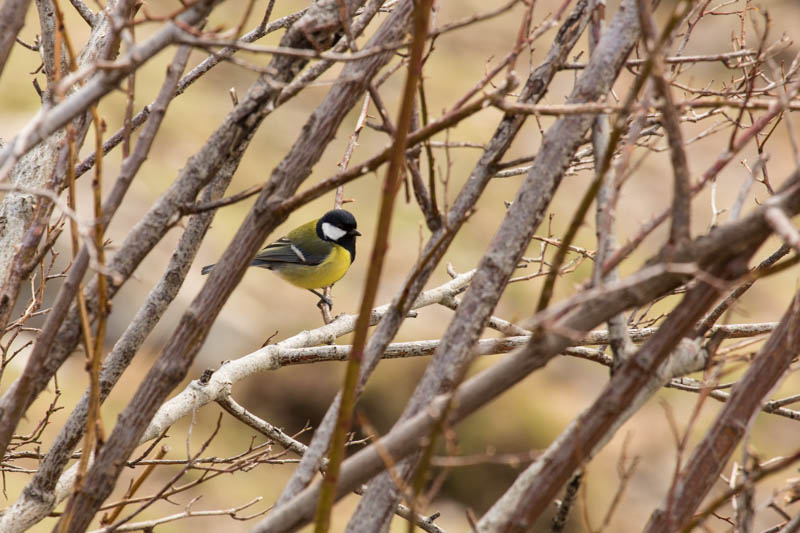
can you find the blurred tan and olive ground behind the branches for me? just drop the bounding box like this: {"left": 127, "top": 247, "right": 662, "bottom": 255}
{"left": 0, "top": 0, "right": 800, "bottom": 532}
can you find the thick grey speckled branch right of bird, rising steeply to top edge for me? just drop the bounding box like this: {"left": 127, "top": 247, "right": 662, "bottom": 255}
{"left": 346, "top": 2, "right": 639, "bottom": 530}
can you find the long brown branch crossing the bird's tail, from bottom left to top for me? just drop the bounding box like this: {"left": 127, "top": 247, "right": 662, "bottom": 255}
{"left": 55, "top": 4, "right": 410, "bottom": 532}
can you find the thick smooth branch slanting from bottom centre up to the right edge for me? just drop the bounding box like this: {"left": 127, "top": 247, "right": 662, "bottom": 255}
{"left": 255, "top": 175, "right": 800, "bottom": 532}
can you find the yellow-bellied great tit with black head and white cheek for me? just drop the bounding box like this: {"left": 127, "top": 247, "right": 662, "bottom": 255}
{"left": 200, "top": 209, "right": 361, "bottom": 305}
